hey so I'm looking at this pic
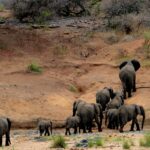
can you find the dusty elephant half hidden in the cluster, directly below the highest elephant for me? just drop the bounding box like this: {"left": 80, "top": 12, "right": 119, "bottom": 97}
{"left": 106, "top": 92, "right": 124, "bottom": 110}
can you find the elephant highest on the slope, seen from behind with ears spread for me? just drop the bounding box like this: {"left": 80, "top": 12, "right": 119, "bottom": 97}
{"left": 119, "top": 59, "right": 140, "bottom": 99}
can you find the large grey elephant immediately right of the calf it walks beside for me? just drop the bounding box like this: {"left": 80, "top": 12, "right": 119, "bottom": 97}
{"left": 73, "top": 100, "right": 103, "bottom": 133}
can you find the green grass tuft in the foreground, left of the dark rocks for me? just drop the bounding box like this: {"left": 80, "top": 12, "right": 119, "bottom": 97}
{"left": 52, "top": 136, "right": 67, "bottom": 148}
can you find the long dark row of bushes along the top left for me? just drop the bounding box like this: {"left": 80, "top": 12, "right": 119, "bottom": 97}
{"left": 12, "top": 0, "right": 85, "bottom": 22}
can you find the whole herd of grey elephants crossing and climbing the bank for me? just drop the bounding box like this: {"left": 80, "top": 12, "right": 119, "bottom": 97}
{"left": 0, "top": 59, "right": 145, "bottom": 146}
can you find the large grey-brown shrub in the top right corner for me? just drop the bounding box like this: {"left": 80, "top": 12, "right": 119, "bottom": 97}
{"left": 101, "top": 0, "right": 150, "bottom": 31}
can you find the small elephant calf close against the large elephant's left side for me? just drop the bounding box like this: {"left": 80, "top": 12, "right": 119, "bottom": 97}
{"left": 65, "top": 116, "right": 80, "bottom": 135}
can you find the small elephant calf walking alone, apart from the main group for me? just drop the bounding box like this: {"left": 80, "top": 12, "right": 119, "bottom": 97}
{"left": 38, "top": 120, "right": 52, "bottom": 136}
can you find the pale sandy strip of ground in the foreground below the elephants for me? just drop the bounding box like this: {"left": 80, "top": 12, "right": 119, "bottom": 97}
{"left": 3, "top": 129, "right": 149, "bottom": 150}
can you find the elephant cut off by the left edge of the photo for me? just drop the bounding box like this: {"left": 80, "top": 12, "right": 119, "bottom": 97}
{"left": 0, "top": 117, "right": 11, "bottom": 146}
